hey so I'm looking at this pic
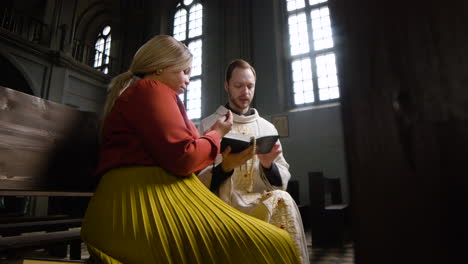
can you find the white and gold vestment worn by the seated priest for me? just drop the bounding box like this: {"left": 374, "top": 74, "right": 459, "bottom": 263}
{"left": 198, "top": 106, "right": 309, "bottom": 263}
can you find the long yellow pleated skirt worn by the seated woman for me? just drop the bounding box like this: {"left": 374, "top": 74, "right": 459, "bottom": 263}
{"left": 81, "top": 167, "right": 299, "bottom": 264}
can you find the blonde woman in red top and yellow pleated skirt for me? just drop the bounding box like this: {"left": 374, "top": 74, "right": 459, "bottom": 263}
{"left": 81, "top": 35, "right": 299, "bottom": 264}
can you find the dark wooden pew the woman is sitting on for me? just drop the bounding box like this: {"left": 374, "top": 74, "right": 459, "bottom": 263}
{"left": 0, "top": 87, "right": 98, "bottom": 260}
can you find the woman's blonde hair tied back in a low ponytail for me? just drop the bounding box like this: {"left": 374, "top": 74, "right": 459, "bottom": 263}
{"left": 102, "top": 35, "right": 192, "bottom": 133}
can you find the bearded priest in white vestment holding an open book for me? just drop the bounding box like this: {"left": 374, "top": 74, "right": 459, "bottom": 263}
{"left": 198, "top": 59, "right": 309, "bottom": 263}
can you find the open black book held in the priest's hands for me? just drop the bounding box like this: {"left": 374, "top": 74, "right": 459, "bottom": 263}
{"left": 221, "top": 134, "right": 279, "bottom": 154}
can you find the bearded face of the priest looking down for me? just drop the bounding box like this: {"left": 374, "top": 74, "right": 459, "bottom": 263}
{"left": 224, "top": 68, "right": 255, "bottom": 114}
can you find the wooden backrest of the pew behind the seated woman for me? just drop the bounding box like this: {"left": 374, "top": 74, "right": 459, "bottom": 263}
{"left": 0, "top": 86, "right": 98, "bottom": 196}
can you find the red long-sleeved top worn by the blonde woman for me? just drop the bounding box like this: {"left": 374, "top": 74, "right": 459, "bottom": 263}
{"left": 96, "top": 79, "right": 220, "bottom": 176}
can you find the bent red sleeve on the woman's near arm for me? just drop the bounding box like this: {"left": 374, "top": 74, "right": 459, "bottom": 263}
{"left": 117, "top": 79, "right": 220, "bottom": 175}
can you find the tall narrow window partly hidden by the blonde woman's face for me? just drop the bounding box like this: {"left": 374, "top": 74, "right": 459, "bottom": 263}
{"left": 173, "top": 0, "right": 203, "bottom": 119}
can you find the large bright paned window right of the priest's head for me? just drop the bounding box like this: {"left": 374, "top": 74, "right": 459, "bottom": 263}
{"left": 285, "top": 0, "right": 340, "bottom": 106}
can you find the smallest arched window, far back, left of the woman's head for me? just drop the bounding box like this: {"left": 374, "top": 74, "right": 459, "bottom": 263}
{"left": 93, "top": 25, "right": 111, "bottom": 74}
